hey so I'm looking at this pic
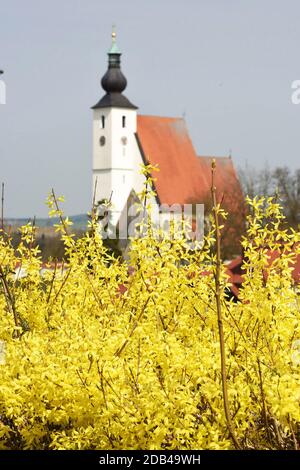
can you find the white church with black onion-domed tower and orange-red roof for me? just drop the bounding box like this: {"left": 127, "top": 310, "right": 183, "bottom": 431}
{"left": 92, "top": 32, "right": 242, "bottom": 233}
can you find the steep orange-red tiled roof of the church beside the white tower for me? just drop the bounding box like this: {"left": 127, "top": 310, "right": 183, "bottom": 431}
{"left": 137, "top": 116, "right": 242, "bottom": 204}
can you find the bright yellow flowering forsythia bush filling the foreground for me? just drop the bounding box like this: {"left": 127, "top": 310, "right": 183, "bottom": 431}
{"left": 0, "top": 171, "right": 300, "bottom": 449}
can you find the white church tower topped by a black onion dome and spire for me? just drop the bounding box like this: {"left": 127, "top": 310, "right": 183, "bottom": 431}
{"left": 92, "top": 31, "right": 137, "bottom": 223}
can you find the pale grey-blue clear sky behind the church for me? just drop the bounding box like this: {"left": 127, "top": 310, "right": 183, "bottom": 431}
{"left": 0, "top": 0, "right": 300, "bottom": 217}
